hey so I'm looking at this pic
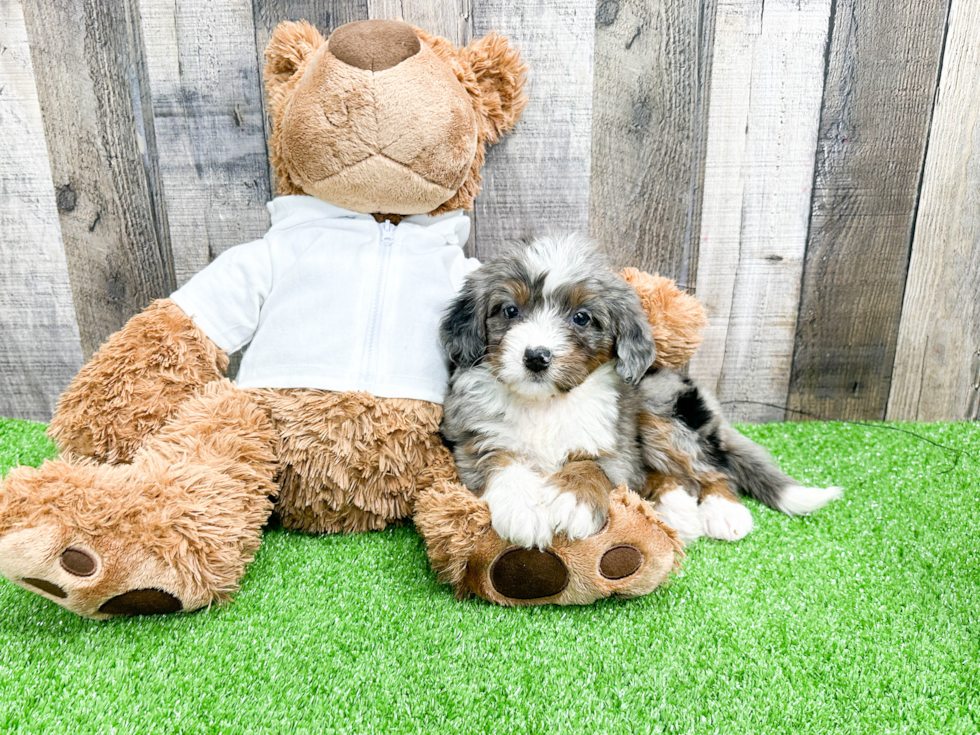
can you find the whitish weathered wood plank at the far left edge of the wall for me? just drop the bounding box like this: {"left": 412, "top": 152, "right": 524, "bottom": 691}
{"left": 0, "top": 0, "right": 82, "bottom": 421}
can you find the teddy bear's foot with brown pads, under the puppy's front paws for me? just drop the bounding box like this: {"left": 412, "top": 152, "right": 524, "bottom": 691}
{"left": 415, "top": 486, "right": 683, "bottom": 605}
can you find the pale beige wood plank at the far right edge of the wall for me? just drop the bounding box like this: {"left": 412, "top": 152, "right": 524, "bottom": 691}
{"left": 887, "top": 0, "right": 980, "bottom": 421}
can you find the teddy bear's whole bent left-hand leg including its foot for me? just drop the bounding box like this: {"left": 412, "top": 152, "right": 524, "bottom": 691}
{"left": 0, "top": 380, "right": 276, "bottom": 620}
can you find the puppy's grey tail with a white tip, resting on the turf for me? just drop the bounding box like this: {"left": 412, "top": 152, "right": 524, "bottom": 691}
{"left": 724, "top": 426, "right": 843, "bottom": 515}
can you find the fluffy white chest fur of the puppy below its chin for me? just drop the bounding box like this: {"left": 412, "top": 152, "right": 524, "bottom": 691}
{"left": 468, "top": 361, "right": 620, "bottom": 473}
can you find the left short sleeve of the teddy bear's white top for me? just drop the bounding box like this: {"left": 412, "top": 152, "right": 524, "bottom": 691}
{"left": 170, "top": 240, "right": 272, "bottom": 353}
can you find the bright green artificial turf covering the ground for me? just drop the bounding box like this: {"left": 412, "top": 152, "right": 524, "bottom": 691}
{"left": 0, "top": 421, "right": 980, "bottom": 734}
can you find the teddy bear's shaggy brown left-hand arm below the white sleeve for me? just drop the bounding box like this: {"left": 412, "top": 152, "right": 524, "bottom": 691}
{"left": 49, "top": 299, "right": 228, "bottom": 463}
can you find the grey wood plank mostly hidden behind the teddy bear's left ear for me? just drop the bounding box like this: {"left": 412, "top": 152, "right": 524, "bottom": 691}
{"left": 253, "top": 0, "right": 368, "bottom": 191}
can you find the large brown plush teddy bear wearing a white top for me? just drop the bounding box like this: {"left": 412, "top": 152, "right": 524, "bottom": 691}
{"left": 0, "top": 21, "right": 700, "bottom": 619}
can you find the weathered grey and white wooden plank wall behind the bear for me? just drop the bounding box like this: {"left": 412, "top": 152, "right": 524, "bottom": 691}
{"left": 0, "top": 0, "right": 980, "bottom": 420}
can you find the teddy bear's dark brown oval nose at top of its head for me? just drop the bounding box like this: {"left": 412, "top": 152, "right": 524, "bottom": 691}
{"left": 327, "top": 20, "right": 421, "bottom": 71}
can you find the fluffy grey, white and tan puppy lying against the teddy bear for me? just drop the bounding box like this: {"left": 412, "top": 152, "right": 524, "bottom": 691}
{"left": 440, "top": 236, "right": 840, "bottom": 548}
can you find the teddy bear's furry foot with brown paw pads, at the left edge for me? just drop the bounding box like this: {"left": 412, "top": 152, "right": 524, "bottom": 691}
{"left": 0, "top": 461, "right": 271, "bottom": 620}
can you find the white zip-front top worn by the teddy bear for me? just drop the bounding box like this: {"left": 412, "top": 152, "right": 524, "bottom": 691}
{"left": 170, "top": 196, "right": 479, "bottom": 403}
